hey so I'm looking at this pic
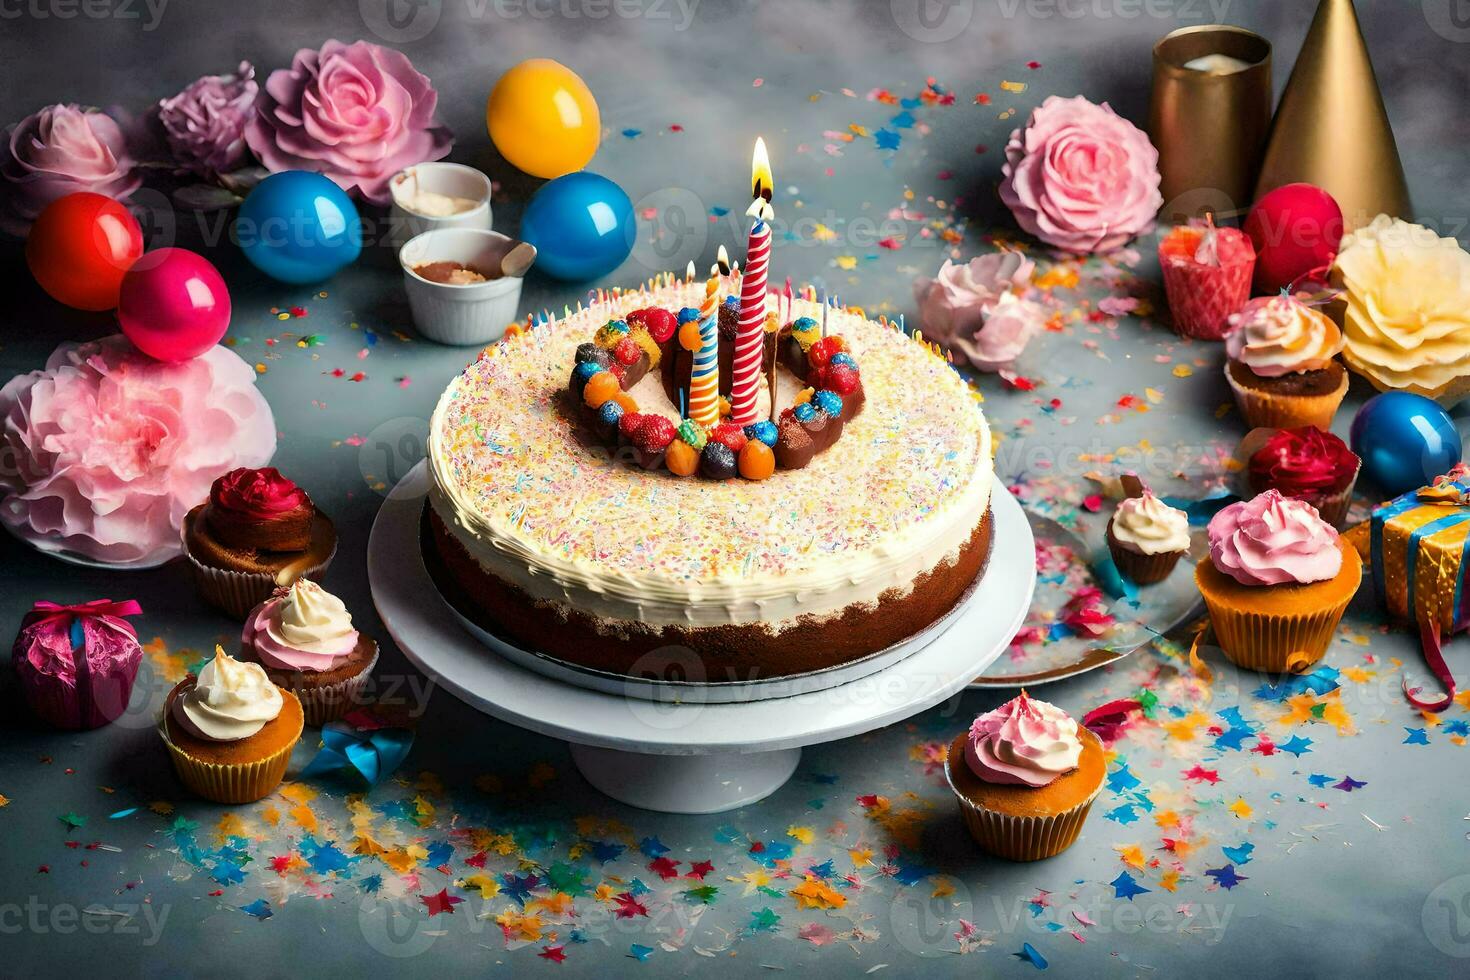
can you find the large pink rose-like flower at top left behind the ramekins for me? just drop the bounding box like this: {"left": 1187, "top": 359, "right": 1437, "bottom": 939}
{"left": 245, "top": 41, "right": 454, "bottom": 204}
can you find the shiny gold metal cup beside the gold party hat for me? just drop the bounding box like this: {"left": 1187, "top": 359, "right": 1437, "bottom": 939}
{"left": 1148, "top": 24, "right": 1272, "bottom": 222}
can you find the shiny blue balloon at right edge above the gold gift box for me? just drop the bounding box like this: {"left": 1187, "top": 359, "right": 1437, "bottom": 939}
{"left": 1351, "top": 391, "right": 1463, "bottom": 497}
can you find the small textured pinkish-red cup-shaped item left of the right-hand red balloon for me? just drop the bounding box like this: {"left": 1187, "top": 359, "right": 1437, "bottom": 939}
{"left": 1158, "top": 219, "right": 1255, "bottom": 341}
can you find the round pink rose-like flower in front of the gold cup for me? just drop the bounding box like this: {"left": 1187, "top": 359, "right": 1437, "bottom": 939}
{"left": 1001, "top": 96, "right": 1164, "bottom": 253}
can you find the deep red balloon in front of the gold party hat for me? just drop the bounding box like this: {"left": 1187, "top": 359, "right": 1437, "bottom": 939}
{"left": 1245, "top": 184, "right": 1342, "bottom": 295}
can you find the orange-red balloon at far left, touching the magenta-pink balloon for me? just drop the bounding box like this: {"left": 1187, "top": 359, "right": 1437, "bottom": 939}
{"left": 25, "top": 191, "right": 143, "bottom": 311}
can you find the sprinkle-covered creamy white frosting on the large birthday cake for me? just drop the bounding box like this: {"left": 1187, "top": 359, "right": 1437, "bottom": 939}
{"left": 429, "top": 284, "right": 992, "bottom": 632}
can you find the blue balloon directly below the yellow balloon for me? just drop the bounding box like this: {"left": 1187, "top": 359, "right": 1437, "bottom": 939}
{"left": 520, "top": 170, "right": 635, "bottom": 282}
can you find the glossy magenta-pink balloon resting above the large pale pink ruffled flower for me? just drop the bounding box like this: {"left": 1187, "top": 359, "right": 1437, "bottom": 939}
{"left": 118, "top": 248, "right": 229, "bottom": 361}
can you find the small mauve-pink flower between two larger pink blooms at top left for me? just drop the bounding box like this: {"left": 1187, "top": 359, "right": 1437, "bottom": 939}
{"left": 159, "top": 62, "right": 260, "bottom": 179}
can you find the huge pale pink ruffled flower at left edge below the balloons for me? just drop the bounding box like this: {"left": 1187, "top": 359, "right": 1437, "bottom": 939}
{"left": 0, "top": 335, "right": 275, "bottom": 566}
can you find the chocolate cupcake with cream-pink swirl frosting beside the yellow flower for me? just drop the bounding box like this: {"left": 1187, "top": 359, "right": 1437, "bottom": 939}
{"left": 1225, "top": 295, "right": 1348, "bottom": 429}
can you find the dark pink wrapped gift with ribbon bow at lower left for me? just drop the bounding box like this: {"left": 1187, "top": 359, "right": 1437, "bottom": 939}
{"left": 12, "top": 599, "right": 143, "bottom": 729}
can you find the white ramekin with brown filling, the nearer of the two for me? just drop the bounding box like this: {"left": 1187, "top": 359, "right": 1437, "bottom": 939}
{"left": 398, "top": 228, "right": 522, "bottom": 345}
